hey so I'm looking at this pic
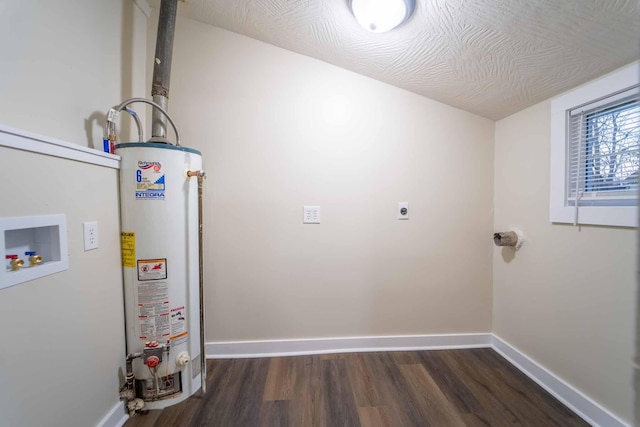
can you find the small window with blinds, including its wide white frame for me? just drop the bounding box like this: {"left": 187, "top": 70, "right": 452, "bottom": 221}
{"left": 550, "top": 64, "right": 640, "bottom": 226}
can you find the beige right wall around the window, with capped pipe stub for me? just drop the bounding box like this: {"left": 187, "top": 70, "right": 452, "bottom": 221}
{"left": 493, "top": 93, "right": 637, "bottom": 423}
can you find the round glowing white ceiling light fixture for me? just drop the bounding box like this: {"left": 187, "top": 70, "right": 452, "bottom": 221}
{"left": 347, "top": 0, "right": 416, "bottom": 33}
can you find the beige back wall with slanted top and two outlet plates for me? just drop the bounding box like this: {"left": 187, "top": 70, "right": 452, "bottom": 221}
{"left": 161, "top": 18, "right": 494, "bottom": 341}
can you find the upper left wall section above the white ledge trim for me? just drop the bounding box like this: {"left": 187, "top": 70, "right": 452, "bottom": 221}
{"left": 0, "top": 0, "right": 146, "bottom": 150}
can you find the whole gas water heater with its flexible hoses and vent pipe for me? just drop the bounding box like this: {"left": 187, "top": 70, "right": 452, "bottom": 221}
{"left": 110, "top": 0, "right": 206, "bottom": 415}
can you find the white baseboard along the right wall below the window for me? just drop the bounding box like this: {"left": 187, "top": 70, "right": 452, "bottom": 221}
{"left": 492, "top": 335, "right": 627, "bottom": 427}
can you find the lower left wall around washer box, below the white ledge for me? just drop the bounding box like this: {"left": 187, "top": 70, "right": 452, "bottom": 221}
{"left": 0, "top": 147, "right": 125, "bottom": 427}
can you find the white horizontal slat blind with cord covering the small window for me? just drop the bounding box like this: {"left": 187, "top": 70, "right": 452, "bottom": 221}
{"left": 565, "top": 86, "right": 640, "bottom": 224}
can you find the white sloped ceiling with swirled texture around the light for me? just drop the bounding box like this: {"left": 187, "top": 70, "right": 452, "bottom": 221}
{"left": 151, "top": 0, "right": 640, "bottom": 119}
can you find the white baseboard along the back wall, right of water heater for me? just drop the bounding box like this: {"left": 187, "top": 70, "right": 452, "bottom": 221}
{"left": 205, "top": 333, "right": 491, "bottom": 359}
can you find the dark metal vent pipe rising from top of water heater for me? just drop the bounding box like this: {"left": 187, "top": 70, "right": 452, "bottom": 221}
{"left": 151, "top": 0, "right": 178, "bottom": 143}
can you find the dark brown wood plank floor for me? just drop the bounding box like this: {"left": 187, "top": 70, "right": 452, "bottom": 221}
{"left": 125, "top": 349, "right": 588, "bottom": 427}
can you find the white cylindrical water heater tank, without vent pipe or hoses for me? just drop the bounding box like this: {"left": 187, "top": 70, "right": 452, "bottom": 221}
{"left": 115, "top": 142, "right": 204, "bottom": 409}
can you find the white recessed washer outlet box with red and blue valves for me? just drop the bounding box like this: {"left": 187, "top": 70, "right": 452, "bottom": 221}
{"left": 0, "top": 215, "right": 69, "bottom": 289}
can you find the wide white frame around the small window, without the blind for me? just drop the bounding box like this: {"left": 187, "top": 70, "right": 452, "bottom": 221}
{"left": 549, "top": 62, "right": 640, "bottom": 227}
